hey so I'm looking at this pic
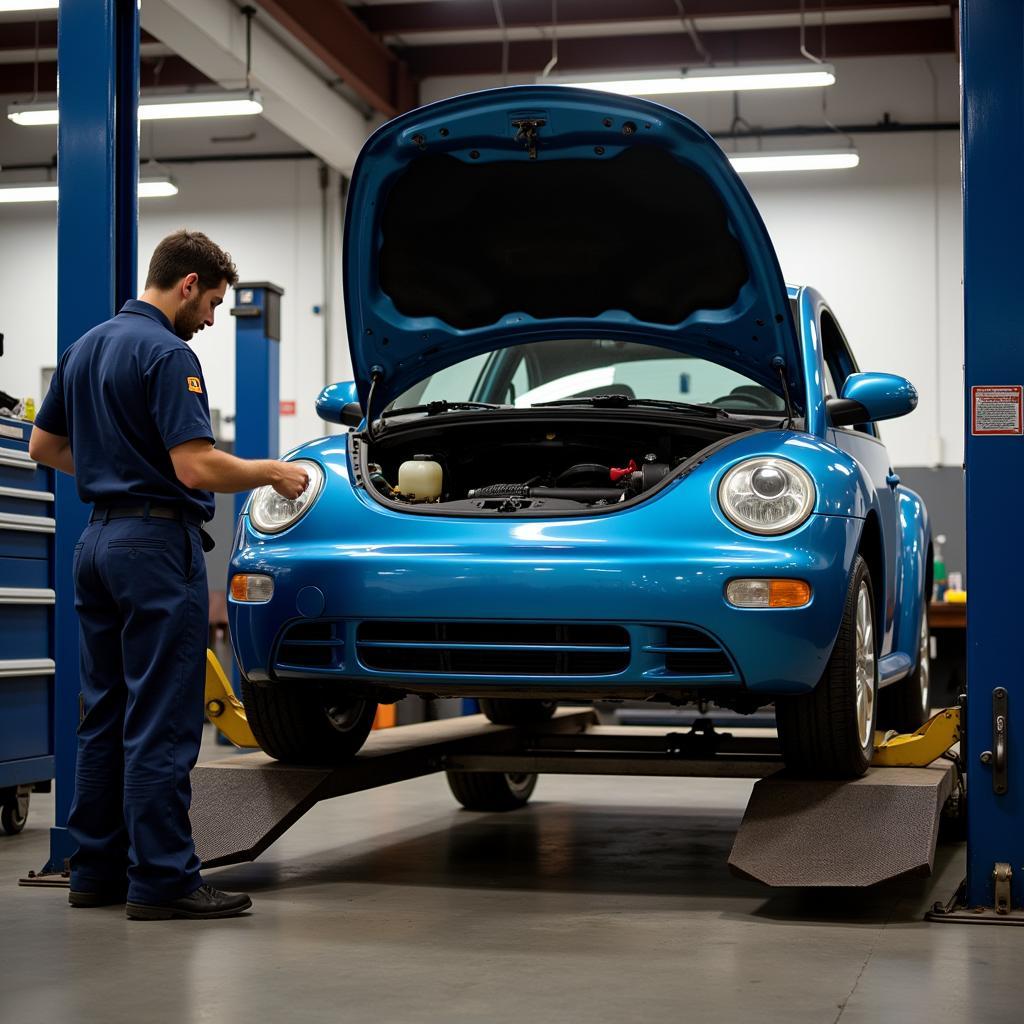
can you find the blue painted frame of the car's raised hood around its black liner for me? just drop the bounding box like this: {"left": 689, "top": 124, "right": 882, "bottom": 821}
{"left": 344, "top": 86, "right": 805, "bottom": 412}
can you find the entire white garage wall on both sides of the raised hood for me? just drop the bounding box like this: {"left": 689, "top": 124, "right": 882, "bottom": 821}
{"left": 0, "top": 56, "right": 963, "bottom": 466}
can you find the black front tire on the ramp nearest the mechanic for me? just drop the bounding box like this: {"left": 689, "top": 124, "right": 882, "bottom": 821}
{"left": 242, "top": 680, "right": 377, "bottom": 765}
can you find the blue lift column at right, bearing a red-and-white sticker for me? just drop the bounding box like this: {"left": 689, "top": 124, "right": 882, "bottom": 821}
{"left": 961, "top": 0, "right": 1024, "bottom": 908}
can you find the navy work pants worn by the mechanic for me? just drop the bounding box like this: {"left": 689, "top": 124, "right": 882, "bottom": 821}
{"left": 68, "top": 517, "right": 209, "bottom": 903}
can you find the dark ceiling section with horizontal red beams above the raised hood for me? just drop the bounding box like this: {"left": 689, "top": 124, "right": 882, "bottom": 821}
{"left": 350, "top": 0, "right": 956, "bottom": 87}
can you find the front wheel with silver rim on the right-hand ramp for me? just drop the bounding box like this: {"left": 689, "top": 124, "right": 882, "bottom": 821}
{"left": 775, "top": 555, "right": 879, "bottom": 778}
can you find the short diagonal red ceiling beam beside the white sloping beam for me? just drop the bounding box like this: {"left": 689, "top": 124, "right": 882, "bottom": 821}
{"left": 260, "top": 0, "right": 416, "bottom": 117}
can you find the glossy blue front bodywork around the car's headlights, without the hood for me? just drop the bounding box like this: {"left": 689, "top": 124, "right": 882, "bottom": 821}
{"left": 228, "top": 423, "right": 921, "bottom": 700}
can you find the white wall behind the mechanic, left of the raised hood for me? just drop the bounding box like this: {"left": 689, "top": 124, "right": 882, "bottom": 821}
{"left": 0, "top": 160, "right": 350, "bottom": 451}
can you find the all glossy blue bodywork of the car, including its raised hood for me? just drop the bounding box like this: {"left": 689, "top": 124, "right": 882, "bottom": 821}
{"left": 228, "top": 94, "right": 930, "bottom": 720}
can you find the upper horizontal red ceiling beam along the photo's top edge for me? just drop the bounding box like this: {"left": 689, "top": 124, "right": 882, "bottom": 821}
{"left": 353, "top": 0, "right": 935, "bottom": 35}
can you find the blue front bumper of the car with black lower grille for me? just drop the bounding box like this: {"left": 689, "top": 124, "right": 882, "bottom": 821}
{"left": 229, "top": 503, "right": 863, "bottom": 700}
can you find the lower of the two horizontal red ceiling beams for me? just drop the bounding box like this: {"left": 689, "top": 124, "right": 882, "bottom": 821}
{"left": 403, "top": 18, "right": 954, "bottom": 78}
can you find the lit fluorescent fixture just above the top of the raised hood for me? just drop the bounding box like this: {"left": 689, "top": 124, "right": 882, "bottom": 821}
{"left": 537, "top": 60, "right": 836, "bottom": 96}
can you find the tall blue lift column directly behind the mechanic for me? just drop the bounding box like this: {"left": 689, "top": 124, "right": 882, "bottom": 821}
{"left": 44, "top": 0, "right": 139, "bottom": 872}
